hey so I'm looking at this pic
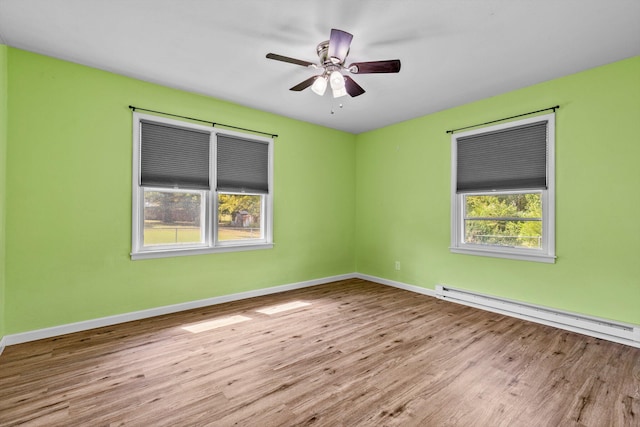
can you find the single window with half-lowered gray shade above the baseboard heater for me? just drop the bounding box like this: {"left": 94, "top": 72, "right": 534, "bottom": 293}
{"left": 451, "top": 114, "right": 555, "bottom": 263}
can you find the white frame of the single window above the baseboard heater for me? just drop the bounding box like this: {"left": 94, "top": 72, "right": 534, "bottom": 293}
{"left": 449, "top": 113, "right": 556, "bottom": 263}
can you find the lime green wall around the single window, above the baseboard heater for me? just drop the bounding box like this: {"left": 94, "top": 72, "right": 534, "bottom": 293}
{"left": 356, "top": 57, "right": 640, "bottom": 324}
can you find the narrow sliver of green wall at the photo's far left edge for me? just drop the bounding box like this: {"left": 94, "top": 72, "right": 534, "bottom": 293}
{"left": 0, "top": 44, "right": 8, "bottom": 338}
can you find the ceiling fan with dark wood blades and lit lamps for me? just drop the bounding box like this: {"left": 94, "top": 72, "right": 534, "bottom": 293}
{"left": 267, "top": 28, "right": 400, "bottom": 98}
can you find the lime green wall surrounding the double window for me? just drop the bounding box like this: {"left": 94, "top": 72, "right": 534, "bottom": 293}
{"left": 4, "top": 48, "right": 355, "bottom": 334}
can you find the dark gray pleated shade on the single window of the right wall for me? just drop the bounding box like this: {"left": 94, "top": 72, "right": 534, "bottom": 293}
{"left": 456, "top": 121, "right": 547, "bottom": 193}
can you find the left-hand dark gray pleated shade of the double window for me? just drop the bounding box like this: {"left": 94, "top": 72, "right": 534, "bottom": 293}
{"left": 140, "top": 121, "right": 210, "bottom": 189}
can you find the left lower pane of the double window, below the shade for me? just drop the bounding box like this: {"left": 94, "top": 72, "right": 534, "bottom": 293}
{"left": 144, "top": 189, "right": 204, "bottom": 246}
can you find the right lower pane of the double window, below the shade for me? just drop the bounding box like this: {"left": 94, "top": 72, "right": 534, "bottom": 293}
{"left": 218, "top": 194, "right": 264, "bottom": 242}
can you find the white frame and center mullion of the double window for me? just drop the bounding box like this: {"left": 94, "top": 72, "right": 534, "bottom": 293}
{"left": 130, "top": 112, "right": 273, "bottom": 260}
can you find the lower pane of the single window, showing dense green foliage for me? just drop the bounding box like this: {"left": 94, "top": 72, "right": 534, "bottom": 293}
{"left": 464, "top": 192, "right": 542, "bottom": 249}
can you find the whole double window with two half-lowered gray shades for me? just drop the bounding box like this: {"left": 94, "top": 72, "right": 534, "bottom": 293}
{"left": 131, "top": 112, "right": 273, "bottom": 259}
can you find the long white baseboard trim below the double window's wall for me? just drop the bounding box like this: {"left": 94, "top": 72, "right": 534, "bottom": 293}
{"left": 0, "top": 273, "right": 356, "bottom": 353}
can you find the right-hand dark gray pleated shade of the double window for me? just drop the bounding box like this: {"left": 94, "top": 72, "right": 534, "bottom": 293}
{"left": 217, "top": 134, "right": 269, "bottom": 194}
